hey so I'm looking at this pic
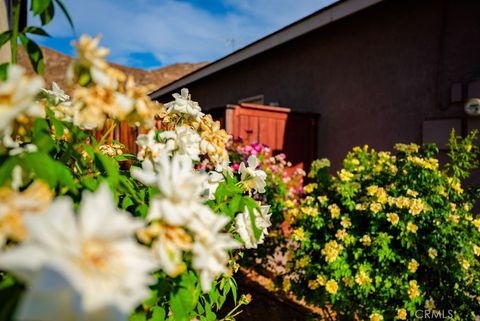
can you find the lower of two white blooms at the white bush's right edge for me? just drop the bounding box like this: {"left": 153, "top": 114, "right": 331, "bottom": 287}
{"left": 235, "top": 205, "right": 272, "bottom": 249}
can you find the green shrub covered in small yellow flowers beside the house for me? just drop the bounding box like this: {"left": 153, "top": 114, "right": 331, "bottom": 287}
{"left": 290, "top": 134, "right": 480, "bottom": 320}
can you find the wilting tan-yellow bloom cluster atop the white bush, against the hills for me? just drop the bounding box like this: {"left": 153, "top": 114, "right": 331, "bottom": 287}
{"left": 67, "top": 35, "right": 165, "bottom": 129}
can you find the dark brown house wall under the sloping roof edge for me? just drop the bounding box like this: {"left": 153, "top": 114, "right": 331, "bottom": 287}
{"left": 155, "top": 0, "right": 480, "bottom": 166}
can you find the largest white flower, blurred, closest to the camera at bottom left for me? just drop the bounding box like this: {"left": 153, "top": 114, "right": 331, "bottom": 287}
{"left": 0, "top": 185, "right": 155, "bottom": 321}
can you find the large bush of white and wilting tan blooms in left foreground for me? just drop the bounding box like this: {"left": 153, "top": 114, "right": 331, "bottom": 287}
{"left": 0, "top": 36, "right": 269, "bottom": 321}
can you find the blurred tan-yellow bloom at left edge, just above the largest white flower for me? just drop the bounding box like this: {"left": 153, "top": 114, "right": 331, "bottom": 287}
{"left": 0, "top": 181, "right": 53, "bottom": 247}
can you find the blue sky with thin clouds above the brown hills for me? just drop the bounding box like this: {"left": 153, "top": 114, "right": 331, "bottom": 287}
{"left": 31, "top": 0, "right": 335, "bottom": 69}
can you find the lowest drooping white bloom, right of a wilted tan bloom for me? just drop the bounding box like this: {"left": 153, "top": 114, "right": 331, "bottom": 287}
{"left": 191, "top": 207, "right": 240, "bottom": 292}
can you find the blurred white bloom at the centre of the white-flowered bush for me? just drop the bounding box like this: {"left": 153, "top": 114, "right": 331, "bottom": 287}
{"left": 132, "top": 154, "right": 206, "bottom": 226}
